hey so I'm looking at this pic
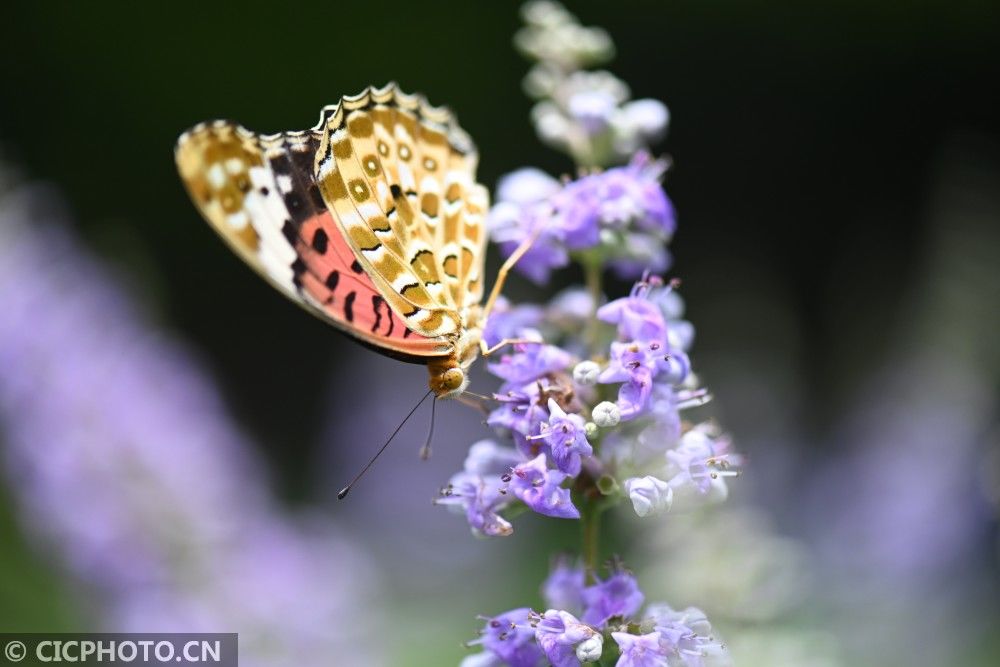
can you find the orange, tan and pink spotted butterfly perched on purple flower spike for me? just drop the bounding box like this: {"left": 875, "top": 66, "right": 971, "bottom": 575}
{"left": 175, "top": 84, "right": 527, "bottom": 398}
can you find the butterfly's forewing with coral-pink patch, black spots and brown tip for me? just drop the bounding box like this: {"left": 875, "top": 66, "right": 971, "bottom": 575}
{"left": 176, "top": 121, "right": 451, "bottom": 363}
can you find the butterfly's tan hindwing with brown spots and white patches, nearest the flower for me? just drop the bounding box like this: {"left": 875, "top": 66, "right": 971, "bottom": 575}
{"left": 315, "top": 84, "right": 488, "bottom": 337}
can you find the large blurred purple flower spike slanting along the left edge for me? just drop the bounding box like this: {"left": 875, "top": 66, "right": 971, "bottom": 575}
{"left": 0, "top": 188, "right": 378, "bottom": 665}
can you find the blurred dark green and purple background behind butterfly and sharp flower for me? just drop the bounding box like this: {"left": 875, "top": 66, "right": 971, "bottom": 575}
{"left": 0, "top": 0, "right": 1000, "bottom": 665}
